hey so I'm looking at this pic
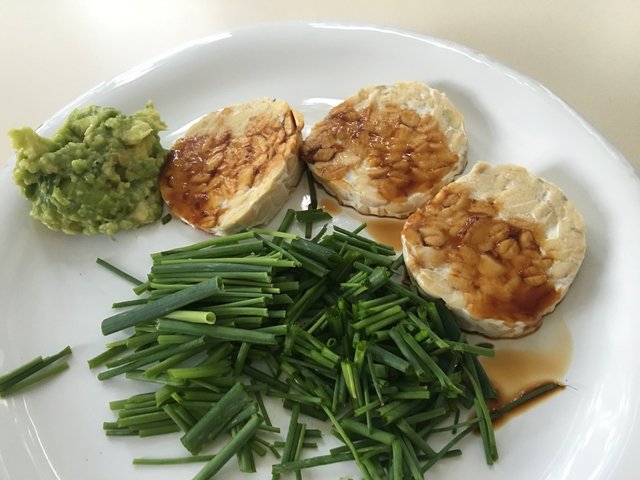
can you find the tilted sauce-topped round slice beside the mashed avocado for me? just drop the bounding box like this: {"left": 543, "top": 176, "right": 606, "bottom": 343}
{"left": 160, "top": 98, "right": 304, "bottom": 234}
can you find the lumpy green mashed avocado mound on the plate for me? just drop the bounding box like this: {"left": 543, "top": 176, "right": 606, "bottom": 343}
{"left": 9, "top": 103, "right": 166, "bottom": 235}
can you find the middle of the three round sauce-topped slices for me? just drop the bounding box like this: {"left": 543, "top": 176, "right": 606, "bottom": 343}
{"left": 302, "top": 82, "right": 467, "bottom": 218}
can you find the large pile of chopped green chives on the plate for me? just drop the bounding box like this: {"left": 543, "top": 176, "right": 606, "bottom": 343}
{"left": 89, "top": 210, "right": 560, "bottom": 480}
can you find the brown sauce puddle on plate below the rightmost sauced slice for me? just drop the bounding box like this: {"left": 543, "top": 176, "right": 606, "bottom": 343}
{"left": 469, "top": 312, "right": 573, "bottom": 427}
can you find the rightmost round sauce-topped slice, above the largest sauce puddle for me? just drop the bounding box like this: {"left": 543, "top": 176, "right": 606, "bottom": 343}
{"left": 402, "top": 163, "right": 586, "bottom": 337}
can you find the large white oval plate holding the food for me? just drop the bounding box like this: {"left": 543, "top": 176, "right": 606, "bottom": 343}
{"left": 0, "top": 23, "right": 640, "bottom": 480}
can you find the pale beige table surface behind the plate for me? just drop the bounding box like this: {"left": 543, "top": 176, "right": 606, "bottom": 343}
{"left": 0, "top": 0, "right": 640, "bottom": 172}
